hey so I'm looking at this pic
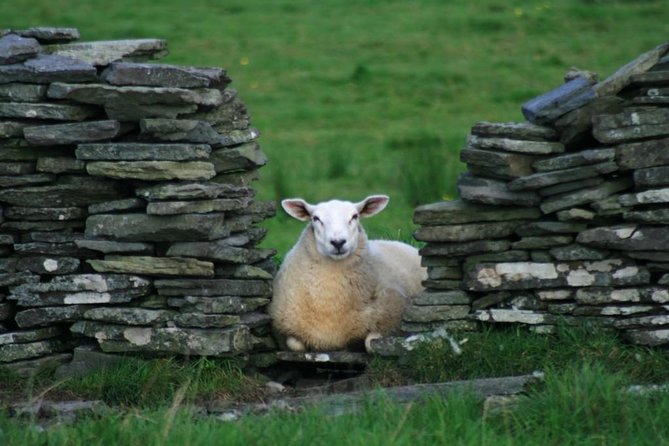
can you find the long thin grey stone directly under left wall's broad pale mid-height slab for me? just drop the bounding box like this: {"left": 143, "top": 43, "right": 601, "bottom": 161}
{"left": 136, "top": 182, "right": 253, "bottom": 201}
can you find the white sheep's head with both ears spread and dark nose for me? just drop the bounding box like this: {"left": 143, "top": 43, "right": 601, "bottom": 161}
{"left": 281, "top": 195, "right": 388, "bottom": 260}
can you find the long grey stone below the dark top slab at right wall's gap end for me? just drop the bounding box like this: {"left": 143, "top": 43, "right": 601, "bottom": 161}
{"left": 414, "top": 221, "right": 522, "bottom": 242}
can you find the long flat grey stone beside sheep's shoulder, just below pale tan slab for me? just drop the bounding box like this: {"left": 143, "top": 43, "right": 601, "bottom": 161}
{"left": 154, "top": 279, "right": 271, "bottom": 297}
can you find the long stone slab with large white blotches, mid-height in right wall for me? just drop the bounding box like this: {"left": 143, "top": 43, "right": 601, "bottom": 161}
{"left": 464, "top": 259, "right": 650, "bottom": 291}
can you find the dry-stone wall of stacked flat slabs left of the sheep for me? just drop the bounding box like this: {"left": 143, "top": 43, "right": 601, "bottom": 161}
{"left": 0, "top": 28, "right": 274, "bottom": 372}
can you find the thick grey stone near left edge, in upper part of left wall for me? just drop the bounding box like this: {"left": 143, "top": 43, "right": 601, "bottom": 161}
{"left": 23, "top": 120, "right": 121, "bottom": 146}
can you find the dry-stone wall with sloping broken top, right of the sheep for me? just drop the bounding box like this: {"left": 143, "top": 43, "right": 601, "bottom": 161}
{"left": 404, "top": 43, "right": 669, "bottom": 345}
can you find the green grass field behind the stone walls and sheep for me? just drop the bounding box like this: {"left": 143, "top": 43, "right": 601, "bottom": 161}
{"left": 0, "top": 0, "right": 669, "bottom": 254}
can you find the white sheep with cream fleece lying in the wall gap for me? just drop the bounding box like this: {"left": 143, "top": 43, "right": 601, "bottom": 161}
{"left": 269, "top": 195, "right": 426, "bottom": 351}
